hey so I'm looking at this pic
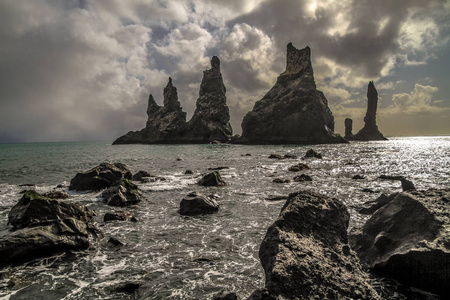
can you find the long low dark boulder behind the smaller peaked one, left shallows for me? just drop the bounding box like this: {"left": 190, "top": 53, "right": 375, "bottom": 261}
{"left": 69, "top": 163, "right": 132, "bottom": 191}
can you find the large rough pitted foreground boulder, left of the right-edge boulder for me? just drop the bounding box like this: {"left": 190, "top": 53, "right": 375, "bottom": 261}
{"left": 249, "top": 191, "right": 379, "bottom": 299}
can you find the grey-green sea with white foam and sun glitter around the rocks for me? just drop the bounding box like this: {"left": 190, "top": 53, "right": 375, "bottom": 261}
{"left": 0, "top": 137, "right": 450, "bottom": 299}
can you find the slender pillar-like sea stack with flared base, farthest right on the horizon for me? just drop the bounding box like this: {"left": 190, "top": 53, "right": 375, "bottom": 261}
{"left": 350, "top": 81, "right": 387, "bottom": 141}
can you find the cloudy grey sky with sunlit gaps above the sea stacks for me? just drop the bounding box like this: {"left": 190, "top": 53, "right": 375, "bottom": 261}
{"left": 0, "top": 0, "right": 450, "bottom": 142}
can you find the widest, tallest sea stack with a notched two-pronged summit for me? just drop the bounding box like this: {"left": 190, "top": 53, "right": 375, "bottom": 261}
{"left": 239, "top": 43, "right": 346, "bottom": 144}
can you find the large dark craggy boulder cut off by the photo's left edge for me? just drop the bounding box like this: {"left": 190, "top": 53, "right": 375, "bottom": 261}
{"left": 0, "top": 191, "right": 101, "bottom": 266}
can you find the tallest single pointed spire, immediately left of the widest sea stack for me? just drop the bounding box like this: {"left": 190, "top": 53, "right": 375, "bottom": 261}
{"left": 185, "top": 56, "right": 233, "bottom": 143}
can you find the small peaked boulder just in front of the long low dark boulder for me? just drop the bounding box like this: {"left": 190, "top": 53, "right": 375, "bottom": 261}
{"left": 100, "top": 178, "right": 145, "bottom": 206}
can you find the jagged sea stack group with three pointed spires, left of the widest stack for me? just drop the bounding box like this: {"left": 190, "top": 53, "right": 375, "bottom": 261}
{"left": 113, "top": 56, "right": 233, "bottom": 144}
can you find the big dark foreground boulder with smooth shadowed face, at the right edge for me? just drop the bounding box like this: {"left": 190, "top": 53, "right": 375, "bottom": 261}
{"left": 351, "top": 189, "right": 450, "bottom": 298}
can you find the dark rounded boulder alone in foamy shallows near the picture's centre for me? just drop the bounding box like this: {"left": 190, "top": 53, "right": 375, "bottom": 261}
{"left": 180, "top": 192, "right": 219, "bottom": 216}
